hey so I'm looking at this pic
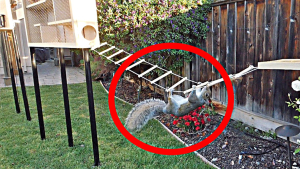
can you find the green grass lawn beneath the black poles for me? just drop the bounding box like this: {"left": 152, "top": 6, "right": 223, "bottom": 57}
{"left": 0, "top": 82, "right": 210, "bottom": 169}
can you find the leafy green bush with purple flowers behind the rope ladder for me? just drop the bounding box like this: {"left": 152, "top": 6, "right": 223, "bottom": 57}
{"left": 97, "top": 0, "right": 211, "bottom": 73}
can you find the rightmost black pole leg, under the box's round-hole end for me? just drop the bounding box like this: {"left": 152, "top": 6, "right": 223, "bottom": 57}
{"left": 83, "top": 49, "right": 100, "bottom": 166}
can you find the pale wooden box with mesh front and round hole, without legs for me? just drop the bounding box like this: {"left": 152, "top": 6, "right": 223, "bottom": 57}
{"left": 23, "top": 0, "right": 100, "bottom": 48}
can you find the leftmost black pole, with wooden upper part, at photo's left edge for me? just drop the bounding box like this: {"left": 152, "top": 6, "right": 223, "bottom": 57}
{"left": 2, "top": 31, "right": 20, "bottom": 113}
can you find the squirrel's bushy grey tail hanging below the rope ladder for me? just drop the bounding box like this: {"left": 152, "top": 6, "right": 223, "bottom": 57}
{"left": 125, "top": 99, "right": 166, "bottom": 132}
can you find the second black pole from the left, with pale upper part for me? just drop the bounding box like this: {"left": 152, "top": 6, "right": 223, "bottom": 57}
{"left": 12, "top": 32, "right": 31, "bottom": 121}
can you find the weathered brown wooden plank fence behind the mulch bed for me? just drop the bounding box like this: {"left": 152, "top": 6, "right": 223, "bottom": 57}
{"left": 180, "top": 0, "right": 300, "bottom": 124}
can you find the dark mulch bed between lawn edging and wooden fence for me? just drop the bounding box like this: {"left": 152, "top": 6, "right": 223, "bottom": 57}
{"left": 102, "top": 80, "right": 300, "bottom": 169}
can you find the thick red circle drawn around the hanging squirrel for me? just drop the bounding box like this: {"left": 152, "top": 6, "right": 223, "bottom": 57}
{"left": 108, "top": 43, "right": 234, "bottom": 155}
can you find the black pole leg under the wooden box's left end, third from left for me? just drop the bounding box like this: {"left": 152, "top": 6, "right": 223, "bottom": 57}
{"left": 30, "top": 47, "right": 46, "bottom": 140}
